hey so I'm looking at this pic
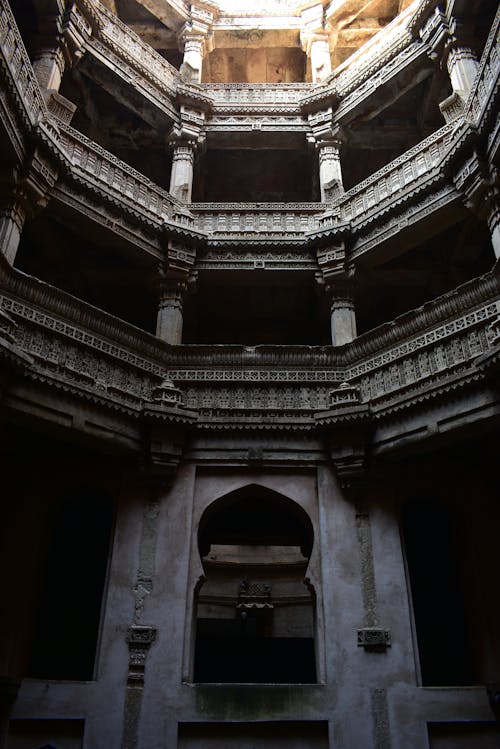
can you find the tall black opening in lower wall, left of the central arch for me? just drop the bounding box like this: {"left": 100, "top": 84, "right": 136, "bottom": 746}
{"left": 27, "top": 494, "right": 112, "bottom": 681}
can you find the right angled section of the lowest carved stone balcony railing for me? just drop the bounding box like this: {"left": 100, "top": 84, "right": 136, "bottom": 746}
{"left": 348, "top": 273, "right": 500, "bottom": 408}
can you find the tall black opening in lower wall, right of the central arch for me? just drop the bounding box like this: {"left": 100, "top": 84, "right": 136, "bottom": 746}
{"left": 403, "top": 502, "right": 475, "bottom": 686}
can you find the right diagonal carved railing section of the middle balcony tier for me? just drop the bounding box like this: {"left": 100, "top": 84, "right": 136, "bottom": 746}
{"left": 319, "top": 123, "right": 457, "bottom": 228}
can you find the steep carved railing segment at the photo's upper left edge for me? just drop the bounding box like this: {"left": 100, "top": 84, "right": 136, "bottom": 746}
{"left": 0, "top": 2, "right": 47, "bottom": 127}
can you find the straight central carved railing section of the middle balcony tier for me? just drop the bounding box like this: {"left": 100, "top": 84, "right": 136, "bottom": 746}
{"left": 190, "top": 203, "right": 325, "bottom": 237}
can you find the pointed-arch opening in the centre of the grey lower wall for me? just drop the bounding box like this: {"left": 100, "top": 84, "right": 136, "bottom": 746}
{"left": 194, "top": 484, "right": 317, "bottom": 683}
